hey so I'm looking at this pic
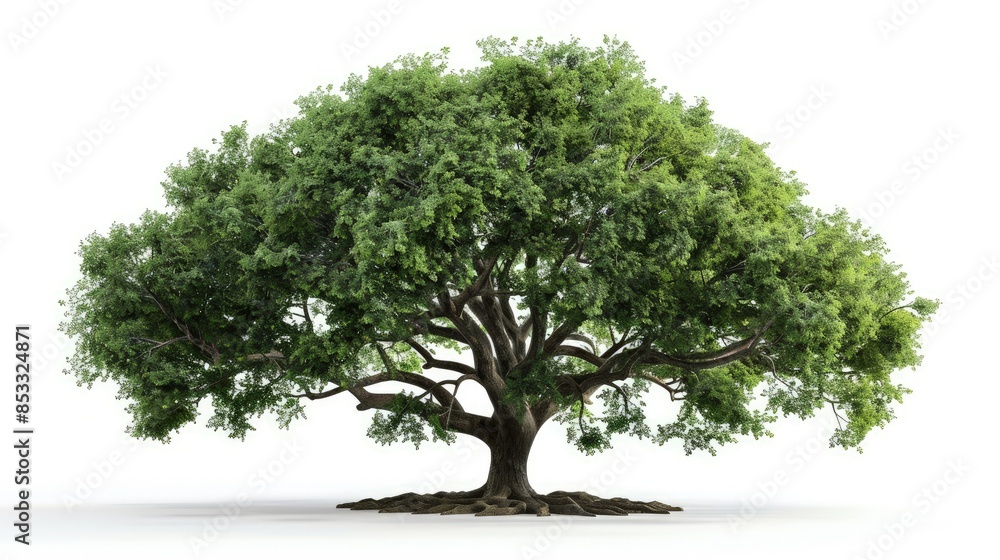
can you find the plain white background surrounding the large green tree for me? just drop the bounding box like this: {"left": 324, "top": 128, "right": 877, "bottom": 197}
{"left": 0, "top": 0, "right": 1000, "bottom": 559}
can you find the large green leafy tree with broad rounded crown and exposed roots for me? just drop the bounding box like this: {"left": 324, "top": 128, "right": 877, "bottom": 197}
{"left": 63, "top": 38, "right": 937, "bottom": 515}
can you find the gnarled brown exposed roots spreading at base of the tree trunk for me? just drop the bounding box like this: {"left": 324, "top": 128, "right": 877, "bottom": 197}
{"left": 337, "top": 488, "right": 683, "bottom": 517}
